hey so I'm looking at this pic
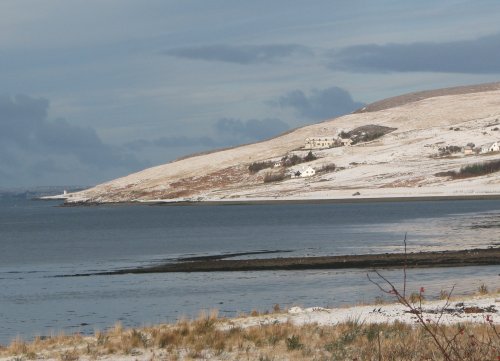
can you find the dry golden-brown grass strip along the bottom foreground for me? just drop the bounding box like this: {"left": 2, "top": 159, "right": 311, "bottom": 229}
{"left": 0, "top": 304, "right": 500, "bottom": 361}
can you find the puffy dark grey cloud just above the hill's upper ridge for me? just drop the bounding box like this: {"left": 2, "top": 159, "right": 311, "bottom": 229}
{"left": 271, "top": 87, "right": 364, "bottom": 120}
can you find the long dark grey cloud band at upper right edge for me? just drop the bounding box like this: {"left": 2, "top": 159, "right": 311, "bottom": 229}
{"left": 329, "top": 34, "right": 500, "bottom": 74}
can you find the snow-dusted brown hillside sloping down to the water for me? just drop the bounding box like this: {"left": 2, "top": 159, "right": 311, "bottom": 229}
{"left": 66, "top": 83, "right": 500, "bottom": 203}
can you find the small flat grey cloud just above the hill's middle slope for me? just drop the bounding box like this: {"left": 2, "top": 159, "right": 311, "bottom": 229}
{"left": 214, "top": 118, "right": 290, "bottom": 141}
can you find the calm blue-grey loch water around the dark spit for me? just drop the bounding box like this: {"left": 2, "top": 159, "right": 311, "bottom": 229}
{"left": 0, "top": 199, "right": 500, "bottom": 344}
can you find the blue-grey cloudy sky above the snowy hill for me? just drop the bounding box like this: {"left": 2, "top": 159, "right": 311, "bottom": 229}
{"left": 0, "top": 0, "right": 500, "bottom": 188}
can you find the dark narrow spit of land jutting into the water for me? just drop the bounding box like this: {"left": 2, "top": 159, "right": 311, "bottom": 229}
{"left": 66, "top": 247, "right": 500, "bottom": 277}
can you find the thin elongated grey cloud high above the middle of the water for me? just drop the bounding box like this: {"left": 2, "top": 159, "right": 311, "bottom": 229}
{"left": 165, "top": 44, "right": 311, "bottom": 65}
